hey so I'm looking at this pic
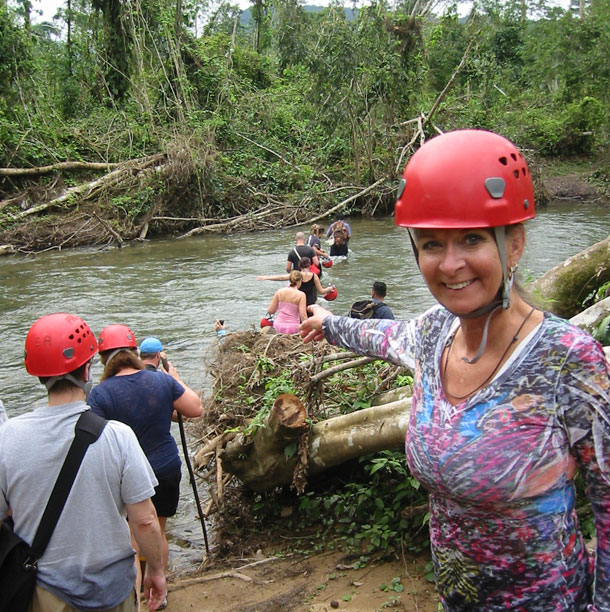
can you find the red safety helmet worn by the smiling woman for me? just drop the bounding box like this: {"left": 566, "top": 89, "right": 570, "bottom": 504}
{"left": 394, "top": 130, "right": 535, "bottom": 229}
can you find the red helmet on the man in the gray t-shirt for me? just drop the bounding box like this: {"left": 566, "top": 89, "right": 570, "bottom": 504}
{"left": 25, "top": 312, "right": 97, "bottom": 377}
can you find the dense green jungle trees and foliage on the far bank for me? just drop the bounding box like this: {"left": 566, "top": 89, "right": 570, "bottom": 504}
{"left": 0, "top": 0, "right": 610, "bottom": 227}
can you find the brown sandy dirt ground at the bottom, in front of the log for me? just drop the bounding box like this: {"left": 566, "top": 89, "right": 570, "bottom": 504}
{"left": 162, "top": 551, "right": 439, "bottom": 612}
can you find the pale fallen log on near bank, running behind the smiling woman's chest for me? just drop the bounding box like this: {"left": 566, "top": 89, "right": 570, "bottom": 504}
{"left": 221, "top": 397, "right": 411, "bottom": 491}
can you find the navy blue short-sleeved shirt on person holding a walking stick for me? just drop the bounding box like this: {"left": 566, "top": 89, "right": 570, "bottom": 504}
{"left": 87, "top": 370, "right": 184, "bottom": 478}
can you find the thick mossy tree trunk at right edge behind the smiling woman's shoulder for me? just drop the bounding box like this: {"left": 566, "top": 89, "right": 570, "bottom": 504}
{"left": 530, "top": 238, "right": 610, "bottom": 319}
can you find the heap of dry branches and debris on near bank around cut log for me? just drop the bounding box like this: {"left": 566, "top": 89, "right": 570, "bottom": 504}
{"left": 190, "top": 328, "right": 402, "bottom": 554}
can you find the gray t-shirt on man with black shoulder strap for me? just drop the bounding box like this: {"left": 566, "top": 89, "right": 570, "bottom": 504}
{"left": 0, "top": 402, "right": 157, "bottom": 610}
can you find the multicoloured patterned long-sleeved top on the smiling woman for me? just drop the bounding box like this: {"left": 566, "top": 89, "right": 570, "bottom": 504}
{"left": 323, "top": 306, "right": 610, "bottom": 612}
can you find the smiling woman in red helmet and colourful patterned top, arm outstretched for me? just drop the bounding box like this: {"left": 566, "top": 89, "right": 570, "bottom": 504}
{"left": 301, "top": 130, "right": 610, "bottom": 612}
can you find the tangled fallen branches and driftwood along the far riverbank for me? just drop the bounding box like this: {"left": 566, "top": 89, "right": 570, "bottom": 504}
{"left": 0, "top": 152, "right": 394, "bottom": 253}
